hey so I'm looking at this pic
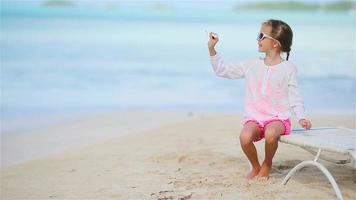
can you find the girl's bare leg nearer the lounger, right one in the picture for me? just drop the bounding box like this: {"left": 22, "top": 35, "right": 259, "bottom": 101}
{"left": 258, "top": 121, "right": 285, "bottom": 178}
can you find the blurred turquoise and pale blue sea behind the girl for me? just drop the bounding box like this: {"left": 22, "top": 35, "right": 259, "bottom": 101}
{"left": 0, "top": 1, "right": 356, "bottom": 132}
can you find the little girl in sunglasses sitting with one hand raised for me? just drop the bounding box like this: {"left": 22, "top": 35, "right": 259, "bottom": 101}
{"left": 208, "top": 19, "right": 311, "bottom": 179}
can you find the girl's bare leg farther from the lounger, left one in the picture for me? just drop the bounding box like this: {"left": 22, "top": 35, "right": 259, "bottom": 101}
{"left": 240, "top": 122, "right": 261, "bottom": 179}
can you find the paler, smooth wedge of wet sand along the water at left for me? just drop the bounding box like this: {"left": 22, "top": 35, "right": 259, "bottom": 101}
{"left": 1, "top": 112, "right": 200, "bottom": 167}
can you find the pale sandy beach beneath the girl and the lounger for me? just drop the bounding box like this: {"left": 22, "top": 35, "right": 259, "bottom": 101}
{"left": 1, "top": 112, "right": 356, "bottom": 200}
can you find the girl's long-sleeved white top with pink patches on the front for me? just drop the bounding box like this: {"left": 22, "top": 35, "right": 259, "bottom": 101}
{"left": 210, "top": 54, "right": 306, "bottom": 122}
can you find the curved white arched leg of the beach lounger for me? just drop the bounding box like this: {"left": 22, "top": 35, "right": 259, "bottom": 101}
{"left": 282, "top": 160, "right": 343, "bottom": 200}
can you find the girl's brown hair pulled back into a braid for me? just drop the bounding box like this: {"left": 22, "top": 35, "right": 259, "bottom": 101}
{"left": 262, "top": 19, "right": 293, "bottom": 60}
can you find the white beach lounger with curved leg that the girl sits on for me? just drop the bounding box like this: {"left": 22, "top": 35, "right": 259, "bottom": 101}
{"left": 280, "top": 127, "right": 356, "bottom": 200}
